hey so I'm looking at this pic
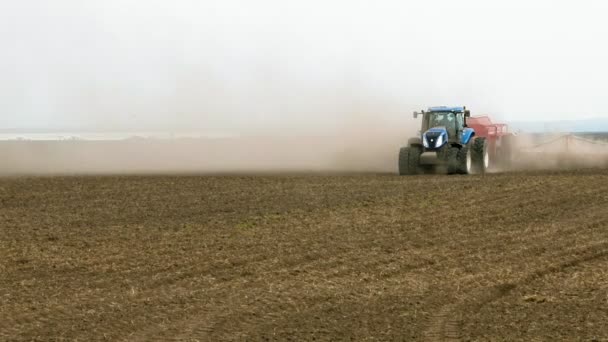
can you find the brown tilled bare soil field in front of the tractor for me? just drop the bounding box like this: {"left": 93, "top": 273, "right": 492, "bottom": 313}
{"left": 0, "top": 170, "right": 608, "bottom": 341}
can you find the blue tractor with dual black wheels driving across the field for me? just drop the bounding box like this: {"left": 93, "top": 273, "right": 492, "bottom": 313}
{"left": 399, "top": 107, "right": 489, "bottom": 175}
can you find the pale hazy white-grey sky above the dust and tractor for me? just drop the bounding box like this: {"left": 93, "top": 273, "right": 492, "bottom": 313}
{"left": 0, "top": 0, "right": 608, "bottom": 133}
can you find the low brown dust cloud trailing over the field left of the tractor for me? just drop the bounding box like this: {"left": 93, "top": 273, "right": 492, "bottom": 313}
{"left": 0, "top": 101, "right": 416, "bottom": 175}
